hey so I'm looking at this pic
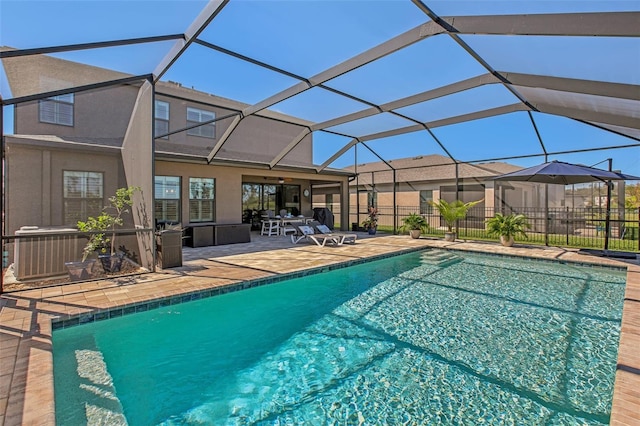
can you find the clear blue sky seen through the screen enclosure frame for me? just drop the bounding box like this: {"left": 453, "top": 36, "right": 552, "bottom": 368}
{"left": 0, "top": 0, "right": 640, "bottom": 175}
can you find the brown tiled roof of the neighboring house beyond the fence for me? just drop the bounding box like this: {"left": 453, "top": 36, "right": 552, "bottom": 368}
{"left": 347, "top": 154, "right": 522, "bottom": 185}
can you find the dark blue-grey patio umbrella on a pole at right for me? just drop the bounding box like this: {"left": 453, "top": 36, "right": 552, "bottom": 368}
{"left": 493, "top": 161, "right": 640, "bottom": 251}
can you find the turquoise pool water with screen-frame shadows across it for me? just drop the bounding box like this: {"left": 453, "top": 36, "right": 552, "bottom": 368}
{"left": 53, "top": 250, "right": 626, "bottom": 425}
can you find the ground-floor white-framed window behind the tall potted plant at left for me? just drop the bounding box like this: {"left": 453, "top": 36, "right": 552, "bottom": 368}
{"left": 62, "top": 171, "right": 104, "bottom": 226}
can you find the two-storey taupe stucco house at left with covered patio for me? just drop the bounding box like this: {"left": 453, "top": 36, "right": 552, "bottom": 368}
{"left": 3, "top": 50, "right": 349, "bottom": 272}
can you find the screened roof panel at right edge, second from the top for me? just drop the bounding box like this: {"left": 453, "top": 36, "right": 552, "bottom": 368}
{"left": 461, "top": 35, "right": 640, "bottom": 84}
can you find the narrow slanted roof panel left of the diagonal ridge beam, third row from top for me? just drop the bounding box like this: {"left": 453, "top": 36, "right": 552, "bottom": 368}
{"left": 396, "top": 84, "right": 519, "bottom": 123}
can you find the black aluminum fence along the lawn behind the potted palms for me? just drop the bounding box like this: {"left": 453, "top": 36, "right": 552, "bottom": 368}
{"left": 350, "top": 206, "right": 640, "bottom": 252}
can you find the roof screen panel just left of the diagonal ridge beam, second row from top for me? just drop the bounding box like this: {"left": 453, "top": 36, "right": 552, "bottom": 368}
{"left": 326, "top": 36, "right": 486, "bottom": 105}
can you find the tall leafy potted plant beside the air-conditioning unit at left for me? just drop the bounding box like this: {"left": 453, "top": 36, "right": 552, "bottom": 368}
{"left": 77, "top": 186, "right": 139, "bottom": 272}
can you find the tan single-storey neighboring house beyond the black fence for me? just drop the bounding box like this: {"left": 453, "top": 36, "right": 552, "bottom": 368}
{"left": 347, "top": 154, "right": 564, "bottom": 230}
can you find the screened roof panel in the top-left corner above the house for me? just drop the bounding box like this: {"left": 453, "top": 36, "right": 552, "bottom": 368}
{"left": 0, "top": 0, "right": 207, "bottom": 47}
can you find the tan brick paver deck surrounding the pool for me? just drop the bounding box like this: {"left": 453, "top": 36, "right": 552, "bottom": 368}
{"left": 0, "top": 234, "right": 640, "bottom": 426}
